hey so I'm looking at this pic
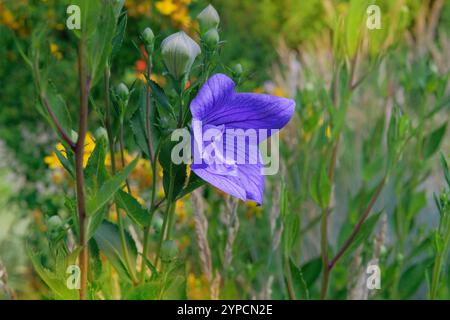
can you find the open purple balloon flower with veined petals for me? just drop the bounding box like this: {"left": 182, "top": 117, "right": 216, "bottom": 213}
{"left": 190, "top": 74, "right": 295, "bottom": 204}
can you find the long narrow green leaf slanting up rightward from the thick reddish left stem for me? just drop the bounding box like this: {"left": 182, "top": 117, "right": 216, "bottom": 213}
{"left": 87, "top": 158, "right": 138, "bottom": 216}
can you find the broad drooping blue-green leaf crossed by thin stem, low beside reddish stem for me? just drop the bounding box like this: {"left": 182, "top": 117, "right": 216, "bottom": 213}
{"left": 94, "top": 221, "right": 137, "bottom": 282}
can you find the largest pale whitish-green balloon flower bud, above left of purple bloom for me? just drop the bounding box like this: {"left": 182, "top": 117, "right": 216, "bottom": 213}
{"left": 161, "top": 31, "right": 201, "bottom": 80}
